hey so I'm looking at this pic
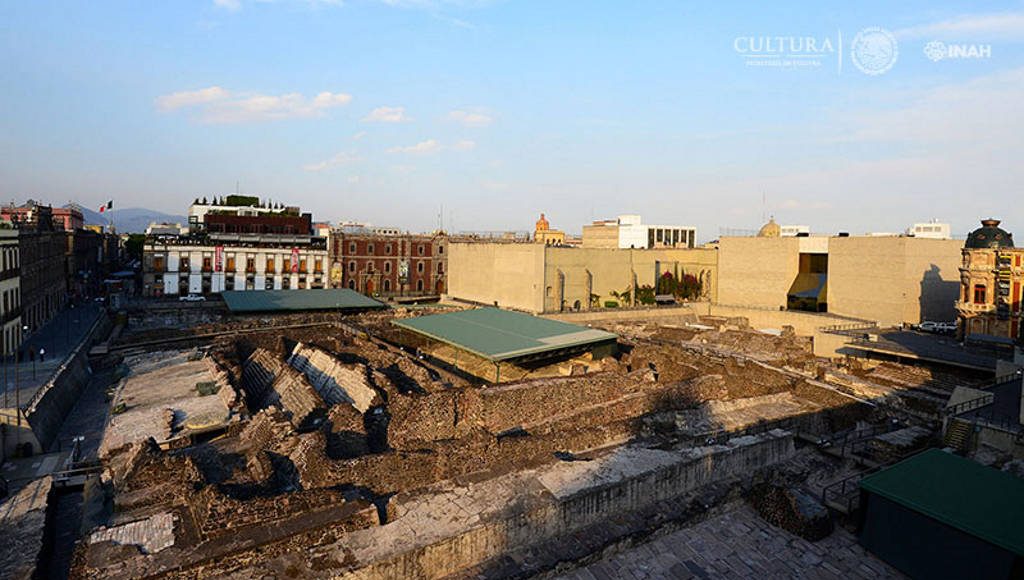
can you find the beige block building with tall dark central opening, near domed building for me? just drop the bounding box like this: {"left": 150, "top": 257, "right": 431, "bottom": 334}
{"left": 718, "top": 231, "right": 963, "bottom": 325}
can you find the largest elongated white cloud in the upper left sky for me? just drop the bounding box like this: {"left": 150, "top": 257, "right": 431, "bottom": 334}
{"left": 156, "top": 86, "right": 352, "bottom": 123}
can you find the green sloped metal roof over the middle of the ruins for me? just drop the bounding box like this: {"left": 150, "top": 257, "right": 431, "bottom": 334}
{"left": 391, "top": 308, "right": 618, "bottom": 361}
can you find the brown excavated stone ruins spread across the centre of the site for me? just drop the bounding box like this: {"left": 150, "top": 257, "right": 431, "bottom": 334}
{"left": 56, "top": 315, "right": 963, "bottom": 578}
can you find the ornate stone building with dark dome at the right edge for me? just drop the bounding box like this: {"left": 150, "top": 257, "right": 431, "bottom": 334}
{"left": 956, "top": 219, "right": 1024, "bottom": 343}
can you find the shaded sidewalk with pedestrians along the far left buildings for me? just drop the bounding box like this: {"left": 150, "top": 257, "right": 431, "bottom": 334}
{"left": 0, "top": 302, "right": 103, "bottom": 408}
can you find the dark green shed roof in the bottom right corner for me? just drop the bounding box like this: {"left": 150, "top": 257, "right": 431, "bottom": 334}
{"left": 860, "top": 449, "right": 1024, "bottom": 555}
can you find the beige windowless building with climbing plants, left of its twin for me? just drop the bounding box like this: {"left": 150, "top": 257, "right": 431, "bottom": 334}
{"left": 449, "top": 243, "right": 718, "bottom": 313}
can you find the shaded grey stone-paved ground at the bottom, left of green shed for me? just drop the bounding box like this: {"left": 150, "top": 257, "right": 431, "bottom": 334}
{"left": 560, "top": 502, "right": 903, "bottom": 580}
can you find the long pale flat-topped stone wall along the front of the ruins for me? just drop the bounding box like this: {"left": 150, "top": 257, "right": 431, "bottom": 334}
{"left": 345, "top": 430, "right": 794, "bottom": 580}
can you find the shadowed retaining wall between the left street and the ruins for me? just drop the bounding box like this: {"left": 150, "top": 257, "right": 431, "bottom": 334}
{"left": 25, "top": 316, "right": 111, "bottom": 453}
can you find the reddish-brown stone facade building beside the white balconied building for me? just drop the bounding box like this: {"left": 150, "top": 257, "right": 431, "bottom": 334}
{"left": 330, "top": 229, "right": 447, "bottom": 296}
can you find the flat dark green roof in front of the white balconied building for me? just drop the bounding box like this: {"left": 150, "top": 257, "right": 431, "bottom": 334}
{"left": 220, "top": 288, "right": 385, "bottom": 313}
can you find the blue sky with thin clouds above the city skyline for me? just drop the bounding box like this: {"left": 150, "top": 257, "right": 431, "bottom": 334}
{"left": 0, "top": 0, "right": 1024, "bottom": 241}
